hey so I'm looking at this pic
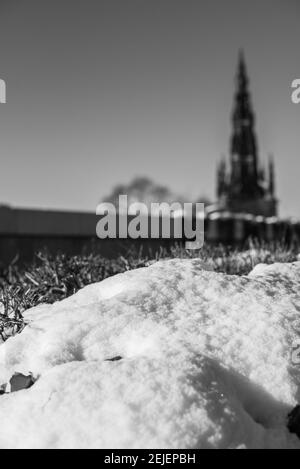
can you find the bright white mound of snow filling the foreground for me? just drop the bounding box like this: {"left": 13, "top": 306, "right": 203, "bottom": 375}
{"left": 0, "top": 260, "right": 300, "bottom": 448}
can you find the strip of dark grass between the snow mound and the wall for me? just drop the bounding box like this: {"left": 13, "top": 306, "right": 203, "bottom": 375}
{"left": 0, "top": 241, "right": 300, "bottom": 341}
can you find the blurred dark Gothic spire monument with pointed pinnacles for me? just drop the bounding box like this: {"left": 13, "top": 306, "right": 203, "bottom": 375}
{"left": 215, "top": 53, "right": 277, "bottom": 217}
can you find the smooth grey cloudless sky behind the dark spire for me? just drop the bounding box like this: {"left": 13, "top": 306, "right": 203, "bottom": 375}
{"left": 0, "top": 0, "right": 300, "bottom": 217}
